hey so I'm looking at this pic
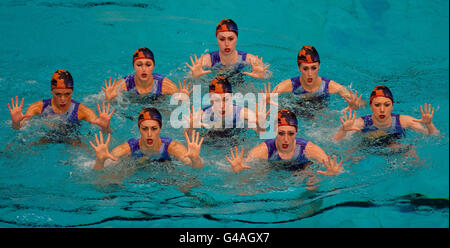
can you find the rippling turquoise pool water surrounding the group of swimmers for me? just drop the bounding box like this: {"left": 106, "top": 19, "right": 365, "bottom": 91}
{"left": 0, "top": 0, "right": 449, "bottom": 228}
